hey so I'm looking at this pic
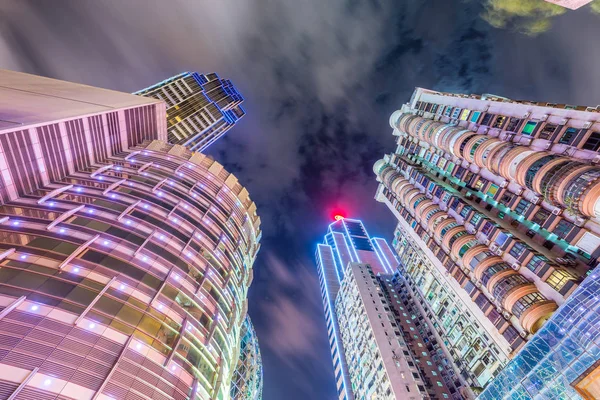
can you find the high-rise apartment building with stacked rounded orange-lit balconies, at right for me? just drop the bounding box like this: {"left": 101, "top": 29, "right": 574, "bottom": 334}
{"left": 374, "top": 88, "right": 600, "bottom": 396}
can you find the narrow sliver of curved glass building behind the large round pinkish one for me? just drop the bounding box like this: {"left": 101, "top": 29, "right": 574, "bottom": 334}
{"left": 231, "top": 316, "right": 263, "bottom": 400}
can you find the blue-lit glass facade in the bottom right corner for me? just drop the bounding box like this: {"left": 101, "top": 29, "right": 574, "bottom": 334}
{"left": 479, "top": 271, "right": 600, "bottom": 400}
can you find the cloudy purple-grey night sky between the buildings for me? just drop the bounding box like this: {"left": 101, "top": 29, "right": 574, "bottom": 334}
{"left": 0, "top": 0, "right": 600, "bottom": 400}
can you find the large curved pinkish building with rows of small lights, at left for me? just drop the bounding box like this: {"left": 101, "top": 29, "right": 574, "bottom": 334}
{"left": 0, "top": 71, "right": 261, "bottom": 400}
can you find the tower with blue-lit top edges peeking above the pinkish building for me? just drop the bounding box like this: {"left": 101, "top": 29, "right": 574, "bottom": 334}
{"left": 135, "top": 72, "right": 245, "bottom": 151}
